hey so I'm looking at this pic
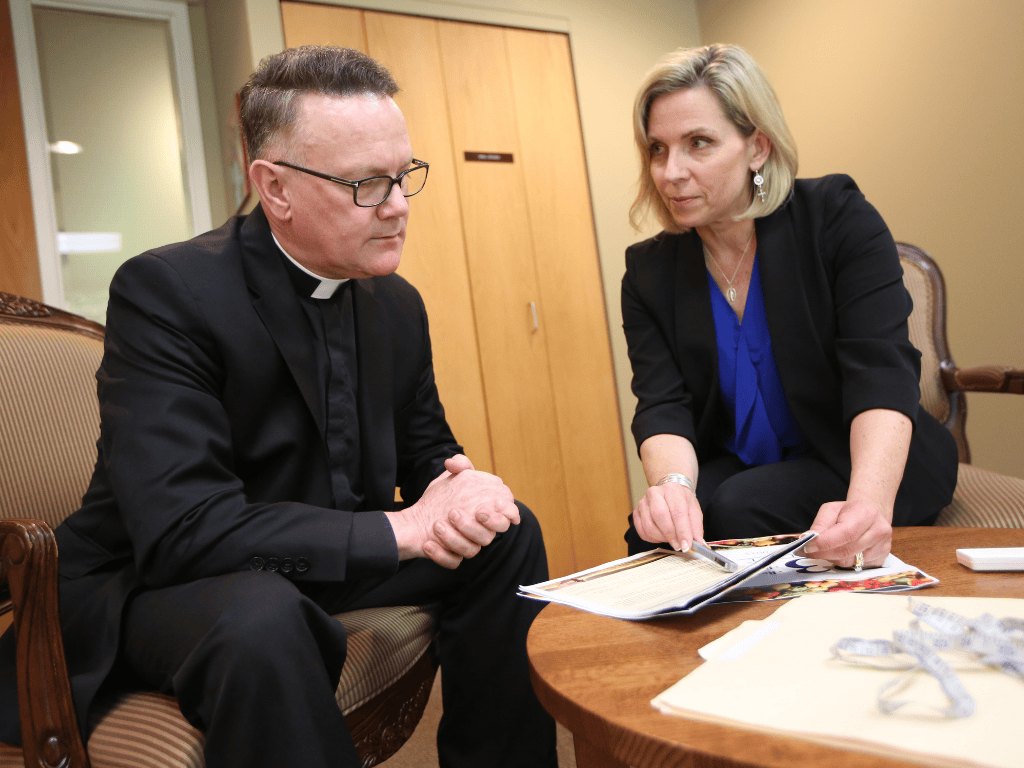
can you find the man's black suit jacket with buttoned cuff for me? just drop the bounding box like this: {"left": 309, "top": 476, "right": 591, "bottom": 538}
{"left": 0, "top": 208, "right": 462, "bottom": 742}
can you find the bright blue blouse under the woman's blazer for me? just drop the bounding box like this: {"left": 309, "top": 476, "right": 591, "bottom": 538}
{"left": 708, "top": 254, "right": 805, "bottom": 467}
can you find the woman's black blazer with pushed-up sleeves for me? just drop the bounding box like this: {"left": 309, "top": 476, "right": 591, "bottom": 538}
{"left": 623, "top": 175, "right": 957, "bottom": 525}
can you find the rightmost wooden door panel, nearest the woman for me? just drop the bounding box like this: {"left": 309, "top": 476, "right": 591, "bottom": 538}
{"left": 505, "top": 30, "right": 630, "bottom": 568}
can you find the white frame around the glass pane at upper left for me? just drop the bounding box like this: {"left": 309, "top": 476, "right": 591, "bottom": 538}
{"left": 7, "top": 0, "right": 211, "bottom": 309}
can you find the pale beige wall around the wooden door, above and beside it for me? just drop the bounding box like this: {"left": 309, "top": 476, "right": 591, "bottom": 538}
{"left": 207, "top": 0, "right": 699, "bottom": 499}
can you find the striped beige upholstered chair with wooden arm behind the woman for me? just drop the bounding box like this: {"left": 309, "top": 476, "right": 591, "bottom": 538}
{"left": 897, "top": 243, "right": 1024, "bottom": 528}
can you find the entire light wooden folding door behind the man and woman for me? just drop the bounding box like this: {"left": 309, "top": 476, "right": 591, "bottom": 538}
{"left": 282, "top": 2, "right": 630, "bottom": 577}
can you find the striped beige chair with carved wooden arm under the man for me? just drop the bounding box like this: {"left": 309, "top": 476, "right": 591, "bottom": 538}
{"left": 0, "top": 293, "right": 436, "bottom": 768}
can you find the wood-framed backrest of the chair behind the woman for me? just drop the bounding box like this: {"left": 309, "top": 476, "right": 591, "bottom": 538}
{"left": 896, "top": 243, "right": 971, "bottom": 463}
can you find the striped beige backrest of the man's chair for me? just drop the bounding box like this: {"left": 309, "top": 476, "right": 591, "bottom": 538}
{"left": 0, "top": 292, "right": 103, "bottom": 527}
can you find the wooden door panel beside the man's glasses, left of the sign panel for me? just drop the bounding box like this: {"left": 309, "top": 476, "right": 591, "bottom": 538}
{"left": 365, "top": 11, "right": 495, "bottom": 472}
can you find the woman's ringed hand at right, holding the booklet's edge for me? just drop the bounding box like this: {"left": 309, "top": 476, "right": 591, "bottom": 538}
{"left": 804, "top": 500, "right": 893, "bottom": 567}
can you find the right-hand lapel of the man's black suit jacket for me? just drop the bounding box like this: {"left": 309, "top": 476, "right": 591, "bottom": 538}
{"left": 352, "top": 279, "right": 398, "bottom": 510}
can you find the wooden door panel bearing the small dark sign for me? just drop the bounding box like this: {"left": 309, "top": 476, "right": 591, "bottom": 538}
{"left": 439, "top": 22, "right": 575, "bottom": 575}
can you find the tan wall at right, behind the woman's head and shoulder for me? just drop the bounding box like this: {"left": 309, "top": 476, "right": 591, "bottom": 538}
{"left": 697, "top": 0, "right": 1024, "bottom": 477}
